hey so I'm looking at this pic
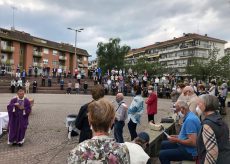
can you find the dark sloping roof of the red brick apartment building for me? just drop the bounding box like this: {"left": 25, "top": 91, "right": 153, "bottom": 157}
{"left": 0, "top": 28, "right": 90, "bottom": 57}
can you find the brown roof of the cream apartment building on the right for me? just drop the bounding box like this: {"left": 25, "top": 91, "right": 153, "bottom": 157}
{"left": 128, "top": 33, "right": 227, "bottom": 54}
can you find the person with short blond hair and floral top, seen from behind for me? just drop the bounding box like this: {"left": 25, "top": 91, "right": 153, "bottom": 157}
{"left": 68, "top": 98, "right": 130, "bottom": 164}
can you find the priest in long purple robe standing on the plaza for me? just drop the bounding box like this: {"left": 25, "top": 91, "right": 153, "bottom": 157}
{"left": 7, "top": 89, "right": 31, "bottom": 146}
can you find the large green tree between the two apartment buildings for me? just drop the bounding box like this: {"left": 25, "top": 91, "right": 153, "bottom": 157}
{"left": 97, "top": 38, "right": 130, "bottom": 73}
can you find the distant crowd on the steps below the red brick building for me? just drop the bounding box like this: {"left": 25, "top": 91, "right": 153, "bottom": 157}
{"left": 6, "top": 66, "right": 88, "bottom": 94}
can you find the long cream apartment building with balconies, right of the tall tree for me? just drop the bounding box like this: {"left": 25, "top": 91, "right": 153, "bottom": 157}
{"left": 125, "top": 33, "right": 227, "bottom": 75}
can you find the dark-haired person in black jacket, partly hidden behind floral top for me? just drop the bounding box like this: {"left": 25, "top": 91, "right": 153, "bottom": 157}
{"left": 76, "top": 84, "right": 105, "bottom": 143}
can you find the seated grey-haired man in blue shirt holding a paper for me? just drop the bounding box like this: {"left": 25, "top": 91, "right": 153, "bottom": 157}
{"left": 159, "top": 101, "right": 201, "bottom": 164}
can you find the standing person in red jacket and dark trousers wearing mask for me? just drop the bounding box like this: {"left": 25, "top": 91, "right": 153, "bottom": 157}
{"left": 145, "top": 85, "right": 157, "bottom": 124}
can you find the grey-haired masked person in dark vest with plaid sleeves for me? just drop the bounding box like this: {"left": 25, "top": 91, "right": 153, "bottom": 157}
{"left": 197, "top": 94, "right": 230, "bottom": 164}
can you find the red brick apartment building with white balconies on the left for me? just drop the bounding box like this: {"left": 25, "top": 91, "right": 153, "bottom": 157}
{"left": 0, "top": 28, "right": 89, "bottom": 76}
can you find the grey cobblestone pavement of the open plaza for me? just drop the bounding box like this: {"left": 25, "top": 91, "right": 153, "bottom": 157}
{"left": 0, "top": 94, "right": 229, "bottom": 164}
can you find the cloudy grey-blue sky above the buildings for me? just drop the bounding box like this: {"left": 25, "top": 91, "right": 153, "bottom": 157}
{"left": 0, "top": 0, "right": 230, "bottom": 59}
